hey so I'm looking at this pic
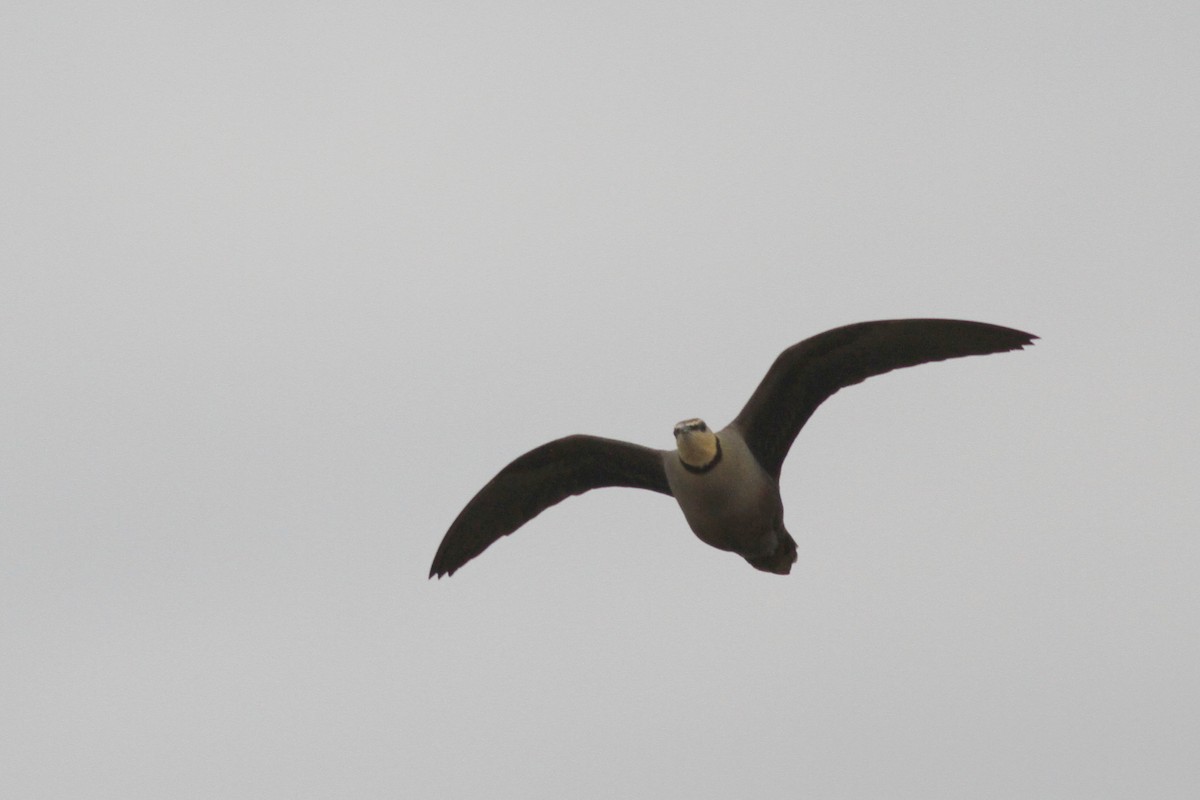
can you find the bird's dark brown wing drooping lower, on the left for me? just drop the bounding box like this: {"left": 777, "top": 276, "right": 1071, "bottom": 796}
{"left": 430, "top": 435, "right": 671, "bottom": 578}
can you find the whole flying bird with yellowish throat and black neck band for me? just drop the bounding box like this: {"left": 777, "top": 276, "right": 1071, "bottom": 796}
{"left": 430, "top": 319, "right": 1037, "bottom": 578}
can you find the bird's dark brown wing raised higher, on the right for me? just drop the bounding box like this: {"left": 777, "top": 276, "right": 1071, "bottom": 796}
{"left": 733, "top": 319, "right": 1037, "bottom": 480}
